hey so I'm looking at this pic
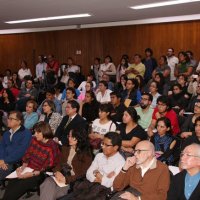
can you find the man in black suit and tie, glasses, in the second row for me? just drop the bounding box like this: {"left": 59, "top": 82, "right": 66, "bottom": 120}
{"left": 55, "top": 100, "right": 86, "bottom": 145}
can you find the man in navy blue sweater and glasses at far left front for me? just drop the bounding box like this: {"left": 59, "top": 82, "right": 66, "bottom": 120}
{"left": 0, "top": 111, "right": 32, "bottom": 181}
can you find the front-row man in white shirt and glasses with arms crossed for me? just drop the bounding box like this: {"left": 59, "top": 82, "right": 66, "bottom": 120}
{"left": 59, "top": 132, "right": 125, "bottom": 200}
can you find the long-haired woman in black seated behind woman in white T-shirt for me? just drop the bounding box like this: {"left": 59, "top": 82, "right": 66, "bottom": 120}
{"left": 79, "top": 91, "right": 100, "bottom": 124}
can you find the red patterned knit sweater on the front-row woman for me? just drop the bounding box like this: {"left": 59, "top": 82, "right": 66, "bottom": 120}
{"left": 23, "top": 137, "right": 60, "bottom": 171}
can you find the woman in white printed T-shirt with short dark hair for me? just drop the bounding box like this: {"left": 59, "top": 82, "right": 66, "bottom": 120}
{"left": 89, "top": 104, "right": 116, "bottom": 153}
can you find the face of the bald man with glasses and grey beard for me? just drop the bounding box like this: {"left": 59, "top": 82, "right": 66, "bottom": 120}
{"left": 134, "top": 143, "right": 151, "bottom": 165}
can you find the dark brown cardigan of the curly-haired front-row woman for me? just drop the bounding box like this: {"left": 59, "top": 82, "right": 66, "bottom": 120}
{"left": 54, "top": 146, "right": 92, "bottom": 183}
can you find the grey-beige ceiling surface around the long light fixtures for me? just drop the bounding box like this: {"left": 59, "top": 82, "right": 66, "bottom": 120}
{"left": 0, "top": 0, "right": 200, "bottom": 31}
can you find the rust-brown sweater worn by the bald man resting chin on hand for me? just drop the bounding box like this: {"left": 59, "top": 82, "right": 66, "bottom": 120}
{"left": 113, "top": 160, "right": 170, "bottom": 200}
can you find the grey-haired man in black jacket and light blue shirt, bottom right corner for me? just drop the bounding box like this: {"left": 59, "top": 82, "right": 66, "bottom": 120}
{"left": 167, "top": 144, "right": 200, "bottom": 200}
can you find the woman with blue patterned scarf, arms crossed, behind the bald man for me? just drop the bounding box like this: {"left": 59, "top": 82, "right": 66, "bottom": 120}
{"left": 150, "top": 117, "right": 176, "bottom": 165}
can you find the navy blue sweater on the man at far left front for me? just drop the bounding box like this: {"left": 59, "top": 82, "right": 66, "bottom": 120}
{"left": 0, "top": 126, "right": 32, "bottom": 164}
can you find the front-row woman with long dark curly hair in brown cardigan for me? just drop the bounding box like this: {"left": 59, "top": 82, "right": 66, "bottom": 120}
{"left": 40, "top": 129, "right": 92, "bottom": 200}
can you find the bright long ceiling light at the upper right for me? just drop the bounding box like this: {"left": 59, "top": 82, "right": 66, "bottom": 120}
{"left": 130, "top": 0, "right": 200, "bottom": 10}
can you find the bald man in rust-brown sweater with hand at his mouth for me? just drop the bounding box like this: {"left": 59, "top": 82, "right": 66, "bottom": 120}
{"left": 113, "top": 141, "right": 170, "bottom": 200}
